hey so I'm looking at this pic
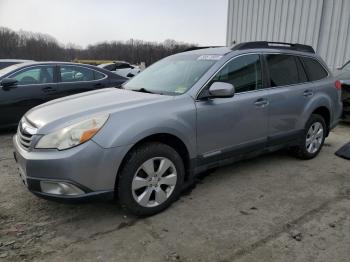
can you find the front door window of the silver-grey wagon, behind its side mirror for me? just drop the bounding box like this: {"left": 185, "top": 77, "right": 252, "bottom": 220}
{"left": 209, "top": 55, "right": 262, "bottom": 93}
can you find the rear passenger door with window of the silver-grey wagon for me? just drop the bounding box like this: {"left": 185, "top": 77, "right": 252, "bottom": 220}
{"left": 264, "top": 54, "right": 313, "bottom": 145}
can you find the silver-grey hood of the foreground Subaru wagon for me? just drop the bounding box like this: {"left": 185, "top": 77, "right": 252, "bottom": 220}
{"left": 25, "top": 88, "right": 173, "bottom": 134}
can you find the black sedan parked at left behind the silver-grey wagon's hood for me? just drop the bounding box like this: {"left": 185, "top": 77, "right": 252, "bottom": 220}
{"left": 0, "top": 62, "right": 128, "bottom": 128}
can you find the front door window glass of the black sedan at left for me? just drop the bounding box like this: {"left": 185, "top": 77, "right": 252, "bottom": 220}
{"left": 10, "top": 66, "right": 53, "bottom": 85}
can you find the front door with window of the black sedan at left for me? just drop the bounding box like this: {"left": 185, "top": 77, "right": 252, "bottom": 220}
{"left": 0, "top": 65, "right": 57, "bottom": 126}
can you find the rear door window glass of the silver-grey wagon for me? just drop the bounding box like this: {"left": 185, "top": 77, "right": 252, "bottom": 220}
{"left": 266, "top": 54, "right": 307, "bottom": 87}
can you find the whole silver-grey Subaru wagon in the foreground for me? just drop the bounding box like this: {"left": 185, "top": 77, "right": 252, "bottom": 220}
{"left": 13, "top": 42, "right": 342, "bottom": 216}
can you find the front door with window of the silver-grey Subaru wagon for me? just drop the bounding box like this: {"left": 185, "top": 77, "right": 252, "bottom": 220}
{"left": 196, "top": 54, "right": 269, "bottom": 159}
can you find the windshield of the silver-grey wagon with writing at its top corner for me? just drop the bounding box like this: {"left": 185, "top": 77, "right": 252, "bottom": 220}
{"left": 123, "top": 55, "right": 217, "bottom": 95}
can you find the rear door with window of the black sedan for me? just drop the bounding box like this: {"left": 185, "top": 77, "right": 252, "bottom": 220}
{"left": 58, "top": 65, "right": 108, "bottom": 97}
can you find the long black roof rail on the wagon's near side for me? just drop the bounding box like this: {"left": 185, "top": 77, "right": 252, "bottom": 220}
{"left": 231, "top": 41, "right": 315, "bottom": 53}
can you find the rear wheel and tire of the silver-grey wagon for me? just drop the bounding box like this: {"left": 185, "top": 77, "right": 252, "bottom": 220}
{"left": 293, "top": 114, "right": 327, "bottom": 160}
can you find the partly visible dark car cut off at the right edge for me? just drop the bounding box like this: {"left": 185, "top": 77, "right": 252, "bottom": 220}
{"left": 336, "top": 61, "right": 350, "bottom": 122}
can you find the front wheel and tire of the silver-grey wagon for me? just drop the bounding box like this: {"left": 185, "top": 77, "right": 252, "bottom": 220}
{"left": 117, "top": 142, "right": 185, "bottom": 216}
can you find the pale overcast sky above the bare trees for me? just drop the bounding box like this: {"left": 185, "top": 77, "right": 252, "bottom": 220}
{"left": 0, "top": 0, "right": 228, "bottom": 47}
